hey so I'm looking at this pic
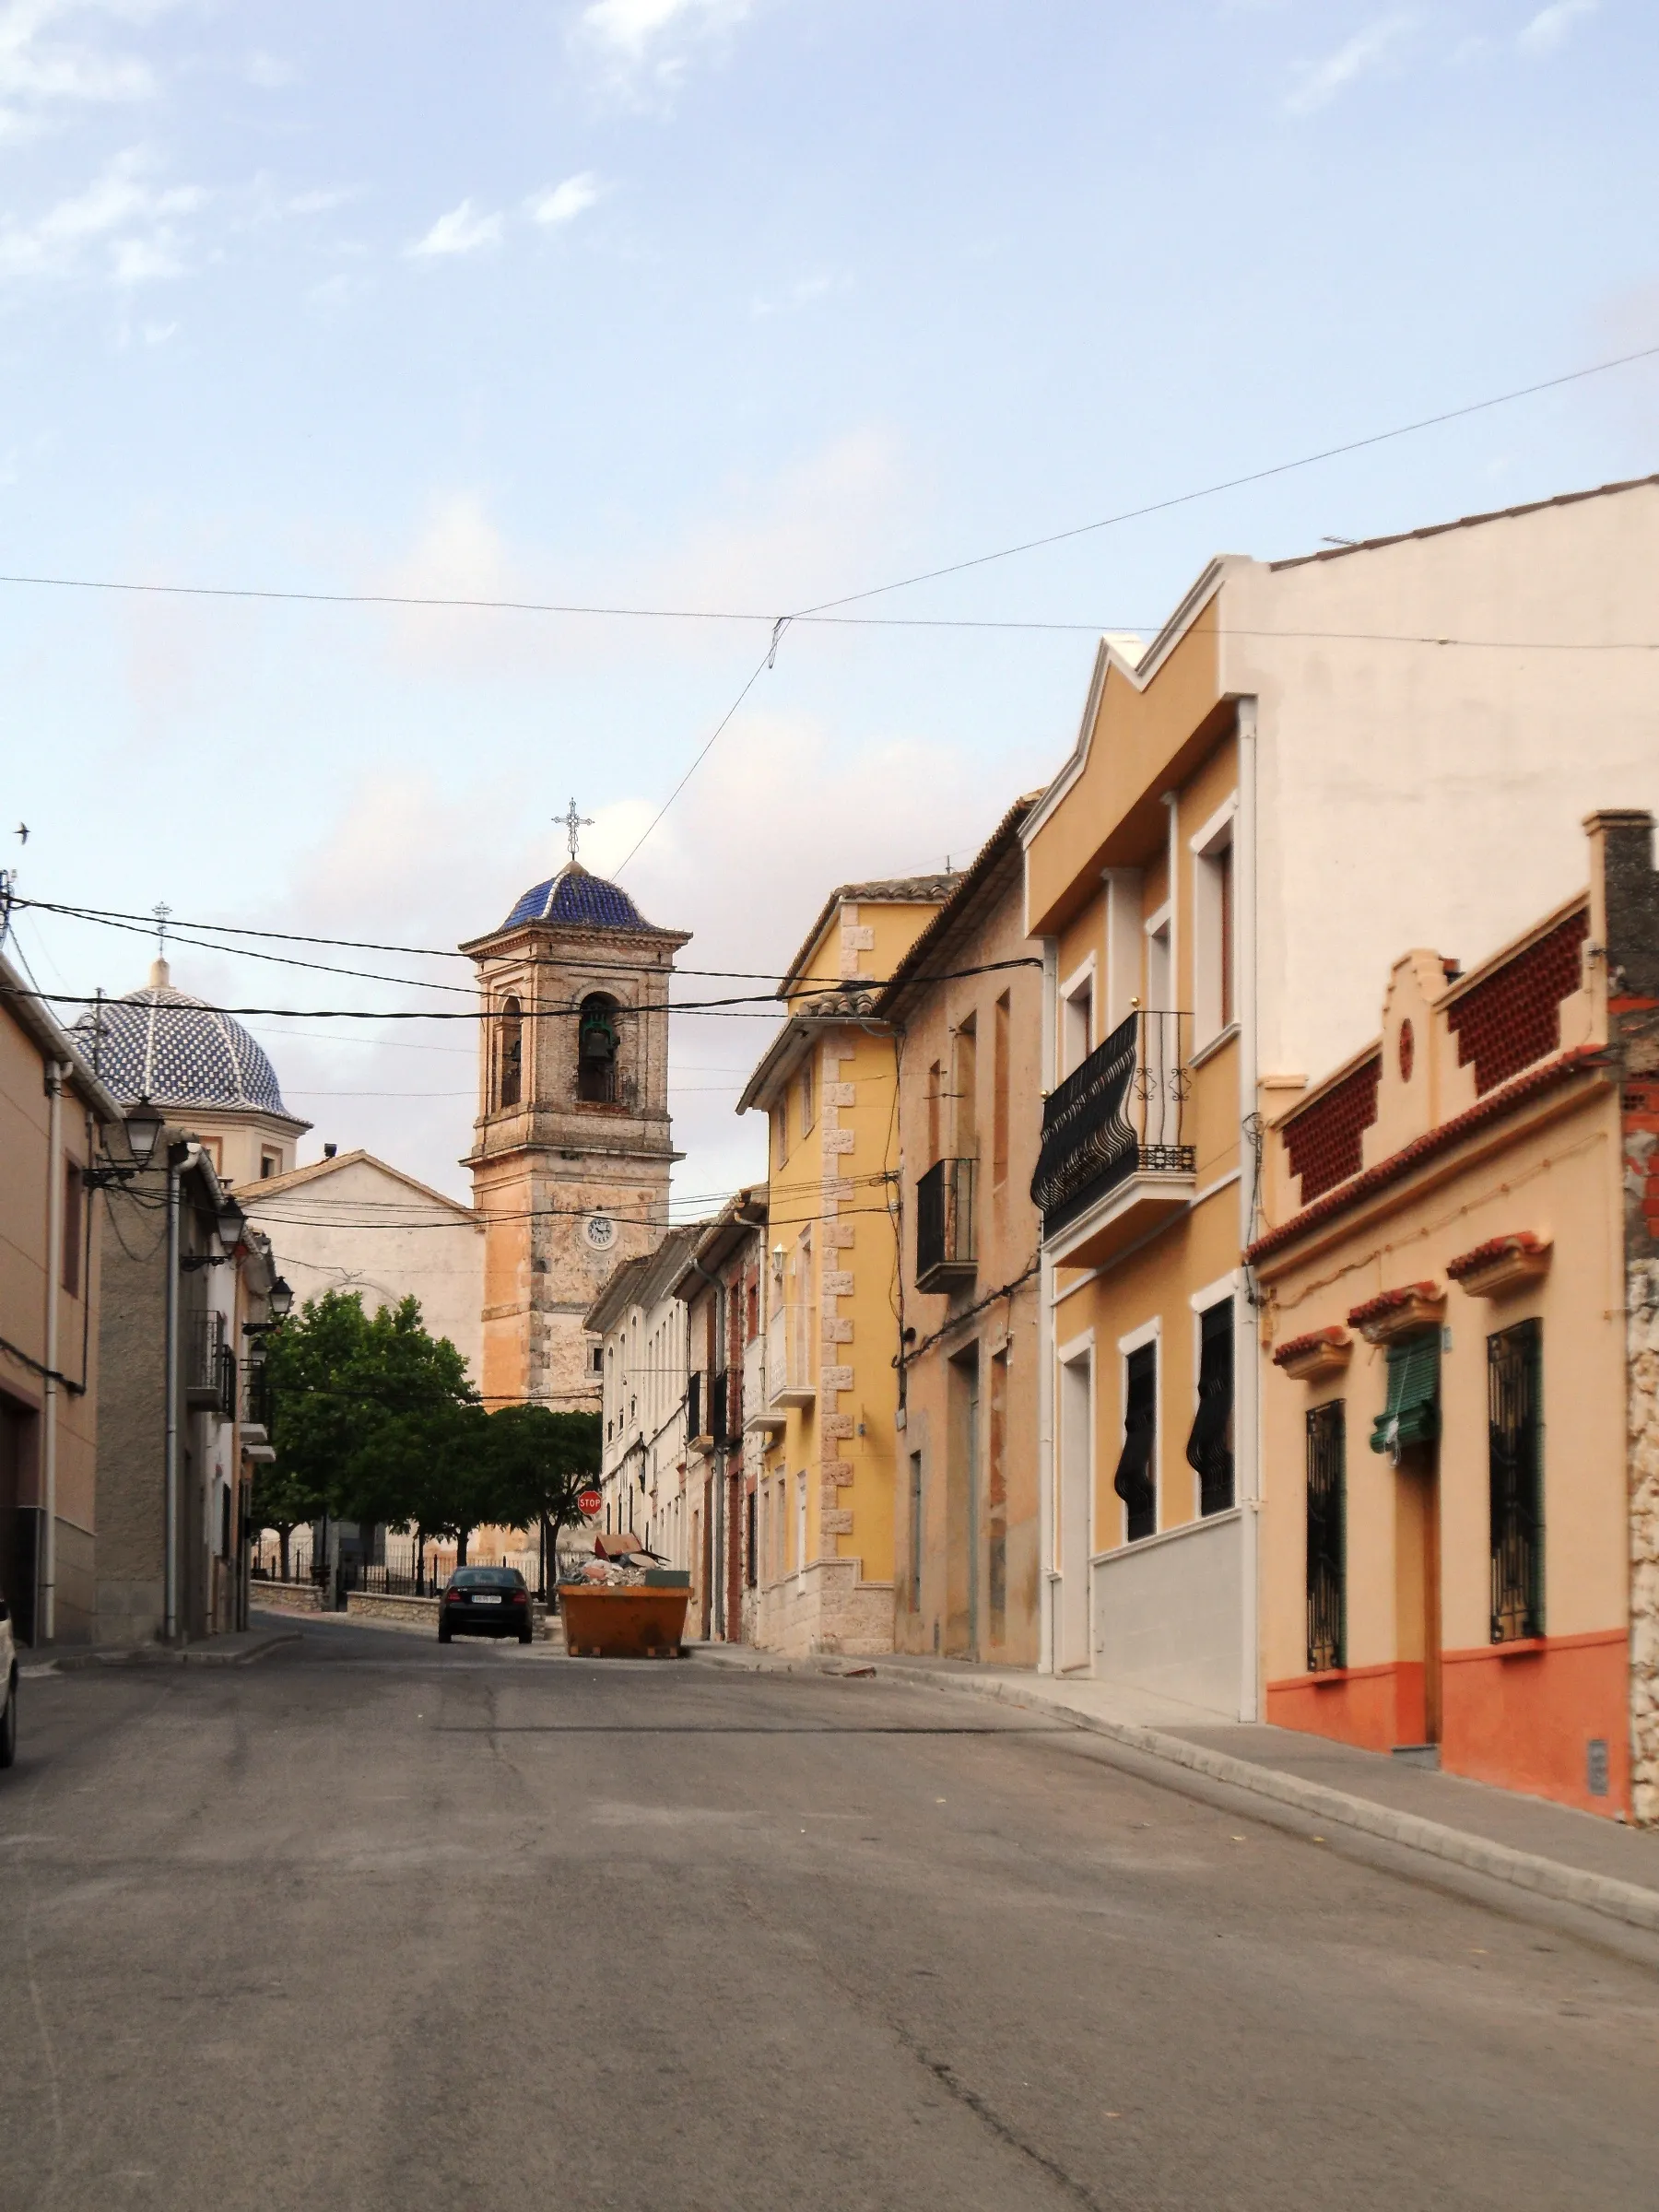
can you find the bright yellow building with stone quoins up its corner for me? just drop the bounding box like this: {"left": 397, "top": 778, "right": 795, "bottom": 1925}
{"left": 739, "top": 876, "right": 958, "bottom": 1653}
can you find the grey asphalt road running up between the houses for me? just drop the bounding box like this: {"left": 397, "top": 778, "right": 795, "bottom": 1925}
{"left": 0, "top": 1624, "right": 1659, "bottom": 2212}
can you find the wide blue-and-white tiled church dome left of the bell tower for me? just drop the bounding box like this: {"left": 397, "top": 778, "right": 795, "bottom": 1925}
{"left": 73, "top": 960, "right": 292, "bottom": 1119}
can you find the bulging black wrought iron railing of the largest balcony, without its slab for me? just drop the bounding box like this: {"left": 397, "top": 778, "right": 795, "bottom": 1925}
{"left": 1030, "top": 1008, "right": 1194, "bottom": 1237}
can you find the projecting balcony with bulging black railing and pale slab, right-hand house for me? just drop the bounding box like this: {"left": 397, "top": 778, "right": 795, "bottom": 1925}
{"left": 1030, "top": 1008, "right": 1194, "bottom": 1267}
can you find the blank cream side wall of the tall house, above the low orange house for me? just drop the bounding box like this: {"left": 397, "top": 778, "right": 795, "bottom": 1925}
{"left": 1218, "top": 485, "right": 1659, "bottom": 1097}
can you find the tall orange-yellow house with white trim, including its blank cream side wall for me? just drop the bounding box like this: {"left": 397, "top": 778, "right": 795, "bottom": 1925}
{"left": 1022, "top": 480, "right": 1659, "bottom": 1719}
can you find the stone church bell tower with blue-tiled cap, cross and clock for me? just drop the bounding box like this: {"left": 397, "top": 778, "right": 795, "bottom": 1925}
{"left": 460, "top": 801, "right": 690, "bottom": 1411}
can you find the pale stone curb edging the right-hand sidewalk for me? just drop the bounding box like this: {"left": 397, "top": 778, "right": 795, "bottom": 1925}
{"left": 697, "top": 1643, "right": 1659, "bottom": 1934}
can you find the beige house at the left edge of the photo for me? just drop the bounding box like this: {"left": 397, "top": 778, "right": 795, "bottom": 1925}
{"left": 0, "top": 956, "right": 122, "bottom": 1643}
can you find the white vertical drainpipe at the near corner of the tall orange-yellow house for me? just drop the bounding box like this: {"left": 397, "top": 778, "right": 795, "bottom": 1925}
{"left": 1232, "top": 699, "right": 1263, "bottom": 1721}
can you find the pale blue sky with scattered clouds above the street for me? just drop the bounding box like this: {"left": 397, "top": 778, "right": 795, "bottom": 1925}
{"left": 0, "top": 0, "right": 1659, "bottom": 1215}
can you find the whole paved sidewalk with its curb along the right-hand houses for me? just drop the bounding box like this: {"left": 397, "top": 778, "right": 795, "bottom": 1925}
{"left": 695, "top": 1643, "right": 1659, "bottom": 1934}
